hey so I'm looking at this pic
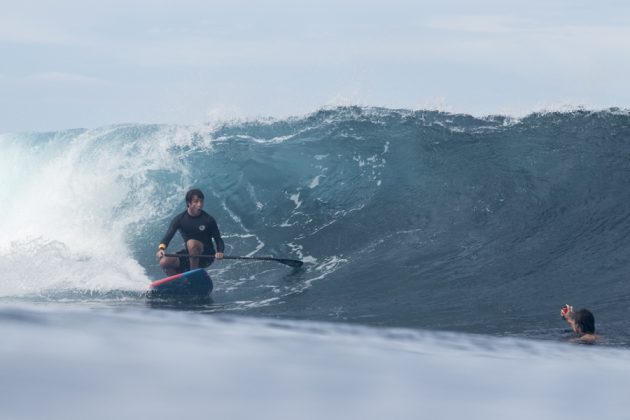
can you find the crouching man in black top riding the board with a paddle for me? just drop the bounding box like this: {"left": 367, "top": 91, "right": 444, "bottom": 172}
{"left": 156, "top": 188, "right": 224, "bottom": 276}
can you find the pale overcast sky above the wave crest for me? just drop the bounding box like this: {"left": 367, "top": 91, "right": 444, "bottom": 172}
{"left": 0, "top": 0, "right": 630, "bottom": 133}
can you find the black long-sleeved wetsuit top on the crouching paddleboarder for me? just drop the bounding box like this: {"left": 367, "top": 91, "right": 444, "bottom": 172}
{"left": 161, "top": 210, "right": 224, "bottom": 254}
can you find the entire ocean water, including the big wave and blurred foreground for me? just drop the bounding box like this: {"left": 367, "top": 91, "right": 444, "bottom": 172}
{"left": 0, "top": 107, "right": 630, "bottom": 419}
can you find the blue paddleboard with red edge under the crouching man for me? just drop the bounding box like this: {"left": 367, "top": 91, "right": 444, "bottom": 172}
{"left": 150, "top": 268, "right": 213, "bottom": 297}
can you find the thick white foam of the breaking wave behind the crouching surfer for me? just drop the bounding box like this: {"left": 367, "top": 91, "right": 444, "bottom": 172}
{"left": 0, "top": 125, "right": 215, "bottom": 296}
